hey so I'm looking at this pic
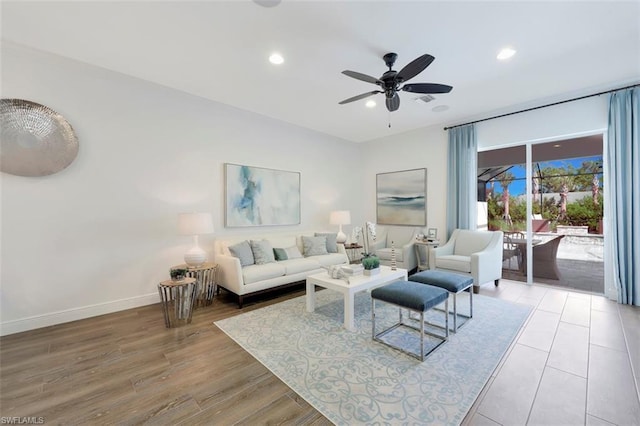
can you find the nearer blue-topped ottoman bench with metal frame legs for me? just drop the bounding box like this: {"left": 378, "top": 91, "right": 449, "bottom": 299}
{"left": 371, "top": 281, "right": 449, "bottom": 361}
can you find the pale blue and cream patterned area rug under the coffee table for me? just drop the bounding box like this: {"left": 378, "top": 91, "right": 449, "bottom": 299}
{"left": 215, "top": 290, "right": 531, "bottom": 425}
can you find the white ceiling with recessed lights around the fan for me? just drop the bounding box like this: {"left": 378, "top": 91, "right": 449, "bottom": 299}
{"left": 2, "top": 0, "right": 640, "bottom": 142}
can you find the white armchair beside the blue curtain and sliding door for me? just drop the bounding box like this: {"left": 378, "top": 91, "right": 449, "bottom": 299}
{"left": 429, "top": 229, "right": 503, "bottom": 293}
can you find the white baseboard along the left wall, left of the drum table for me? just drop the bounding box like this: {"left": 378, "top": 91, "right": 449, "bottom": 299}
{"left": 0, "top": 293, "right": 159, "bottom": 336}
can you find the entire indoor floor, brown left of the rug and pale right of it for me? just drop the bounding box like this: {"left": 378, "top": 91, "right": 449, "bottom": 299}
{"left": 0, "top": 280, "right": 640, "bottom": 425}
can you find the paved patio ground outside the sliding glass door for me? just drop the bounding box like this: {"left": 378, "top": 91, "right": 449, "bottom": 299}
{"left": 502, "top": 234, "right": 604, "bottom": 294}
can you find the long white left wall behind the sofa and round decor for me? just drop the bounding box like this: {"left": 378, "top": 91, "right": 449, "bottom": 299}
{"left": 0, "top": 44, "right": 362, "bottom": 334}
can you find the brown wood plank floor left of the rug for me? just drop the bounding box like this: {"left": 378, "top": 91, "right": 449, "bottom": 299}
{"left": 0, "top": 288, "right": 329, "bottom": 425}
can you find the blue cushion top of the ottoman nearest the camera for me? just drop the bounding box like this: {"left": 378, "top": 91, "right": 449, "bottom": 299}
{"left": 371, "top": 281, "right": 449, "bottom": 312}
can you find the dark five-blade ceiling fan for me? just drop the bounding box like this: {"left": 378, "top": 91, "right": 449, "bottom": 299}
{"left": 338, "top": 53, "right": 453, "bottom": 111}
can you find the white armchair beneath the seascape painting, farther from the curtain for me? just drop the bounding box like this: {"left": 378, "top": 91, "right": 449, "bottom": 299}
{"left": 367, "top": 225, "right": 419, "bottom": 271}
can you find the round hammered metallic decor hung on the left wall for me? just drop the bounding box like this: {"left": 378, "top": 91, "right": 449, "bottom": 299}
{"left": 0, "top": 99, "right": 78, "bottom": 176}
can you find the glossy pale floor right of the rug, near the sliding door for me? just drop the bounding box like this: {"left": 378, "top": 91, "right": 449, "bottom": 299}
{"left": 463, "top": 280, "right": 640, "bottom": 426}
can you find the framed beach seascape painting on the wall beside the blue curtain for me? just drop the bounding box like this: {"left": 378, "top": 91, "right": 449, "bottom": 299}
{"left": 376, "top": 169, "right": 427, "bottom": 226}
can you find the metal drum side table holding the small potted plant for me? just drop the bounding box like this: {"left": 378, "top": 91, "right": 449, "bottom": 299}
{"left": 158, "top": 278, "right": 197, "bottom": 328}
